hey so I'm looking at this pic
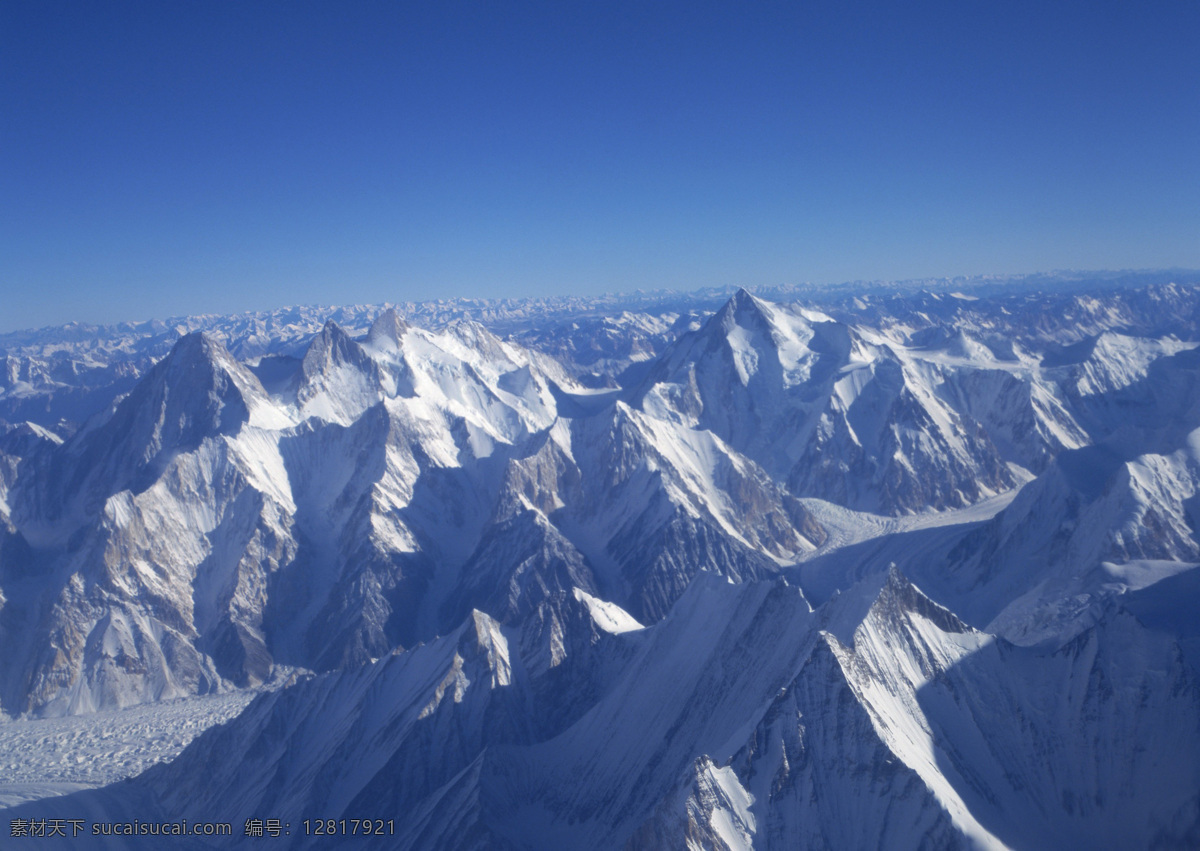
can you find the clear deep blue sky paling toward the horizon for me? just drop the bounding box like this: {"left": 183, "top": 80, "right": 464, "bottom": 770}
{"left": 0, "top": 0, "right": 1200, "bottom": 330}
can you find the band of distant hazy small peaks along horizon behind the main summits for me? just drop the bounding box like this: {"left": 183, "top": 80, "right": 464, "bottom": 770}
{"left": 0, "top": 272, "right": 1200, "bottom": 433}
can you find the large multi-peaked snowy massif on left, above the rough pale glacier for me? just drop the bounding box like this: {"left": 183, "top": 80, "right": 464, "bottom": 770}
{"left": 0, "top": 302, "right": 821, "bottom": 713}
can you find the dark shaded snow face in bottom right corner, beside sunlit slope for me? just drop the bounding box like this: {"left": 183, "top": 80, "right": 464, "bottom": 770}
{"left": 918, "top": 612, "right": 1200, "bottom": 847}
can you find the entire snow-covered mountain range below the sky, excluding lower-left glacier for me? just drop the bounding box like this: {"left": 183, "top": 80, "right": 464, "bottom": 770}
{"left": 0, "top": 274, "right": 1200, "bottom": 849}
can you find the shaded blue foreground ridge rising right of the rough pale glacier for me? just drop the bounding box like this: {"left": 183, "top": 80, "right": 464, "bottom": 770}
{"left": 143, "top": 595, "right": 637, "bottom": 830}
